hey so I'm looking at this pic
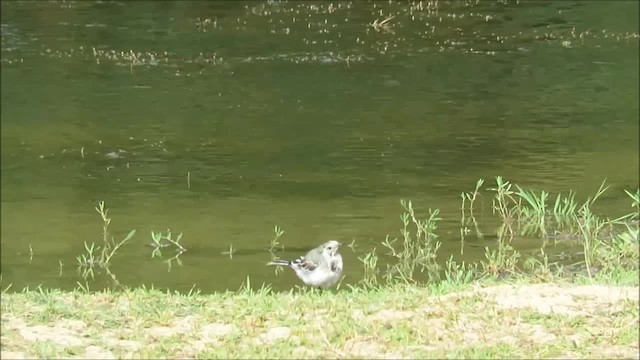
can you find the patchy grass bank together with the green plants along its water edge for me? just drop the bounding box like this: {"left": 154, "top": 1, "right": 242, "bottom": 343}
{"left": 0, "top": 178, "right": 640, "bottom": 359}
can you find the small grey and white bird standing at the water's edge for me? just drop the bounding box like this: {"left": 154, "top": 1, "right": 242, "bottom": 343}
{"left": 267, "top": 240, "right": 342, "bottom": 289}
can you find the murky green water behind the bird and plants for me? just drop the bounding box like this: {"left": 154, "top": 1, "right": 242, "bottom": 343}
{"left": 1, "top": 1, "right": 639, "bottom": 291}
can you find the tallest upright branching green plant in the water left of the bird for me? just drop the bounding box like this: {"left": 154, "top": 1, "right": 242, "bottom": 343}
{"left": 76, "top": 201, "right": 136, "bottom": 285}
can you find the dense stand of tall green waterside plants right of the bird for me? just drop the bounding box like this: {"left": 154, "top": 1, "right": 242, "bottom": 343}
{"left": 358, "top": 177, "right": 640, "bottom": 288}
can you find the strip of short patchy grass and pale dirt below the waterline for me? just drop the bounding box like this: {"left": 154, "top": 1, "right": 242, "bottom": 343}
{"left": 1, "top": 274, "right": 639, "bottom": 359}
